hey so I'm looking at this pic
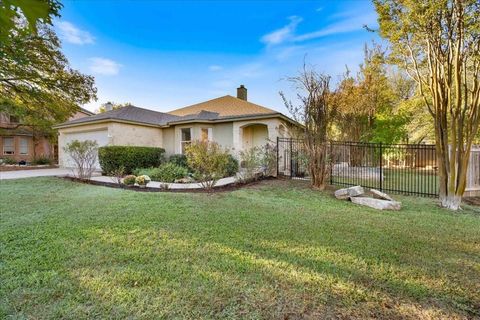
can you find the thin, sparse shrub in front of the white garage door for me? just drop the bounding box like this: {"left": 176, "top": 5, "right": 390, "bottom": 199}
{"left": 63, "top": 140, "right": 98, "bottom": 179}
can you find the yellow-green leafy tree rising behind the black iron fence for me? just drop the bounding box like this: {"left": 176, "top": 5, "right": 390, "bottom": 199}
{"left": 334, "top": 45, "right": 408, "bottom": 143}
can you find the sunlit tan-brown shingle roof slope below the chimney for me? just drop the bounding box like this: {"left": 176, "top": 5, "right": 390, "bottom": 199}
{"left": 168, "top": 96, "right": 278, "bottom": 117}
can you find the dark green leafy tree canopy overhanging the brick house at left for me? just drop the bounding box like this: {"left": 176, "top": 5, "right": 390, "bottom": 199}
{"left": 0, "top": 25, "right": 96, "bottom": 132}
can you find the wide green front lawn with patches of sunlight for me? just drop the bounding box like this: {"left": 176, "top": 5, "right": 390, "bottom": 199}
{"left": 0, "top": 178, "right": 480, "bottom": 319}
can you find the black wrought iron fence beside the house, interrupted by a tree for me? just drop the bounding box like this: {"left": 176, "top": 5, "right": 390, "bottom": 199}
{"left": 277, "top": 138, "right": 438, "bottom": 196}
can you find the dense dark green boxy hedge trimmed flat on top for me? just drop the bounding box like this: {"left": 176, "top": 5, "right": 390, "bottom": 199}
{"left": 98, "top": 146, "right": 165, "bottom": 174}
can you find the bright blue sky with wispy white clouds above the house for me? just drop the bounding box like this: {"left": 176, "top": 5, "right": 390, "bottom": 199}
{"left": 55, "top": 0, "right": 379, "bottom": 112}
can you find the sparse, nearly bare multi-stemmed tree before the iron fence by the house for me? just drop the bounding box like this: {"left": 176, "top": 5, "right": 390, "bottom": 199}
{"left": 280, "top": 64, "right": 335, "bottom": 190}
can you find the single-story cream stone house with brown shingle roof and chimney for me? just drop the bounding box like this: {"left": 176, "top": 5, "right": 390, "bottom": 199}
{"left": 55, "top": 85, "right": 297, "bottom": 167}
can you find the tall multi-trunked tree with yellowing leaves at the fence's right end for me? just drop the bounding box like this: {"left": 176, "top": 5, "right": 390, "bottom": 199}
{"left": 374, "top": 0, "right": 480, "bottom": 210}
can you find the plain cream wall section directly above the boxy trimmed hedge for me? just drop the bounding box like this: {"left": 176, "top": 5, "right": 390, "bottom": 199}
{"left": 108, "top": 122, "right": 163, "bottom": 147}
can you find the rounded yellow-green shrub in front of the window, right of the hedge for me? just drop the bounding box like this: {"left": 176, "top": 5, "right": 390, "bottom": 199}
{"left": 186, "top": 141, "right": 229, "bottom": 189}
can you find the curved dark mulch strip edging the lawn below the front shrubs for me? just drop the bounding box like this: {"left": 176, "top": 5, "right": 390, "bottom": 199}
{"left": 59, "top": 177, "right": 276, "bottom": 193}
